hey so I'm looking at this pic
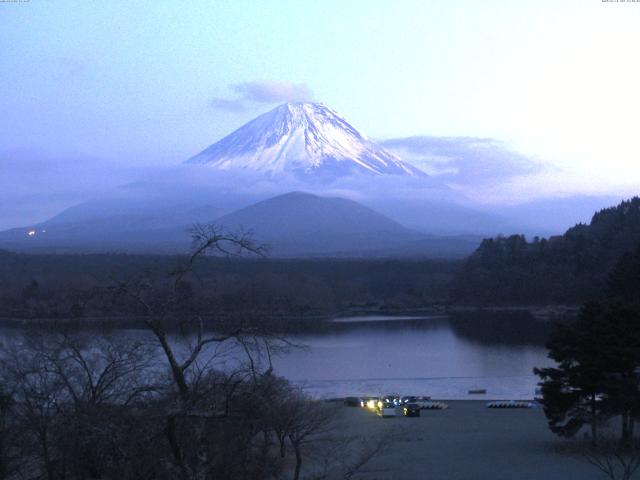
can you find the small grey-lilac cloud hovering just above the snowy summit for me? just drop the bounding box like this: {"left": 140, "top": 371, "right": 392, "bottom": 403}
{"left": 210, "top": 81, "right": 313, "bottom": 112}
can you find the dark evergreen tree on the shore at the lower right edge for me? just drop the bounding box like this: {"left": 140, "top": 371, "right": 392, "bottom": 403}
{"left": 534, "top": 302, "right": 640, "bottom": 443}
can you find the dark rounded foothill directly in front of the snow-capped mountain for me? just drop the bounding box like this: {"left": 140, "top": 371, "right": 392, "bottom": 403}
{"left": 215, "top": 192, "right": 477, "bottom": 257}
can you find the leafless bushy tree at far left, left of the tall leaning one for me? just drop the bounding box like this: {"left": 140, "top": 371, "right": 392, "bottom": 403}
{"left": 0, "top": 331, "right": 156, "bottom": 479}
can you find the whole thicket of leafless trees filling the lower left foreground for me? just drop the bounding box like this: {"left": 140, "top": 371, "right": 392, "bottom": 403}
{"left": 0, "top": 226, "right": 333, "bottom": 480}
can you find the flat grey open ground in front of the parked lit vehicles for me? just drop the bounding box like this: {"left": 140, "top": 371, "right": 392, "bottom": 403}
{"left": 342, "top": 401, "right": 604, "bottom": 480}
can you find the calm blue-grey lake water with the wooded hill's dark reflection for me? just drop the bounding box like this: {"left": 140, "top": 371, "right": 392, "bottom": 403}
{"left": 275, "top": 313, "right": 551, "bottom": 398}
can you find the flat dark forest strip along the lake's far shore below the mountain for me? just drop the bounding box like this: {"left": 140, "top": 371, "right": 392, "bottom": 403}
{"left": 0, "top": 251, "right": 460, "bottom": 323}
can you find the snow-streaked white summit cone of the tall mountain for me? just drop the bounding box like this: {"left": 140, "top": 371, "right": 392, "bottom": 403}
{"left": 186, "top": 103, "right": 426, "bottom": 180}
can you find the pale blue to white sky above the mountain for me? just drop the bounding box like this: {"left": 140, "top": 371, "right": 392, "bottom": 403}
{"left": 0, "top": 0, "right": 640, "bottom": 227}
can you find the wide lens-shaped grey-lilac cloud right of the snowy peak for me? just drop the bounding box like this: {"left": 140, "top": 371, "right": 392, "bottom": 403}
{"left": 382, "top": 136, "right": 548, "bottom": 185}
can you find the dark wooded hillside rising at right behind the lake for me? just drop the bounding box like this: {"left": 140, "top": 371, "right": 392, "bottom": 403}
{"left": 453, "top": 197, "right": 640, "bottom": 304}
